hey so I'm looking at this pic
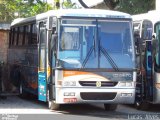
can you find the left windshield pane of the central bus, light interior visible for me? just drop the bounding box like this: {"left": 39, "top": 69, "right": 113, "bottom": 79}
{"left": 58, "top": 19, "right": 98, "bottom": 69}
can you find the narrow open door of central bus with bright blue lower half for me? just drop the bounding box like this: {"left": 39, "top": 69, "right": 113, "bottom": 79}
{"left": 38, "top": 21, "right": 47, "bottom": 101}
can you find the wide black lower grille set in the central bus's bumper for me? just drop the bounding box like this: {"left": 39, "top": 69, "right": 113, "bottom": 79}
{"left": 80, "top": 92, "right": 117, "bottom": 100}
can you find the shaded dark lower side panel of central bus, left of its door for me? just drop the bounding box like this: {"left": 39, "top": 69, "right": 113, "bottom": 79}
{"left": 8, "top": 48, "right": 38, "bottom": 95}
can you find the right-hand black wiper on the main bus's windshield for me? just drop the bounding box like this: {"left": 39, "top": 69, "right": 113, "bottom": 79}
{"left": 100, "top": 46, "right": 119, "bottom": 71}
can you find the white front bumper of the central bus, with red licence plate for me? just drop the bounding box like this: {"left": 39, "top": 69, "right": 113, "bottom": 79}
{"left": 56, "top": 87, "right": 135, "bottom": 104}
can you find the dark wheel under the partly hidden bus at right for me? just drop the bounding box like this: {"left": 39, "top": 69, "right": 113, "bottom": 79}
{"left": 135, "top": 102, "right": 150, "bottom": 110}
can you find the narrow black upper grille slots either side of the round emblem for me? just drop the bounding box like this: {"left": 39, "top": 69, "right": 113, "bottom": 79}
{"left": 79, "top": 81, "right": 118, "bottom": 87}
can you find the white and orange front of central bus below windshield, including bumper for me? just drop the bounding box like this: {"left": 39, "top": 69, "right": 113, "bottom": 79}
{"left": 55, "top": 70, "right": 136, "bottom": 104}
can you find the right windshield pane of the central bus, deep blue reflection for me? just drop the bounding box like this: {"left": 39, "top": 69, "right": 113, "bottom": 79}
{"left": 98, "top": 21, "right": 135, "bottom": 69}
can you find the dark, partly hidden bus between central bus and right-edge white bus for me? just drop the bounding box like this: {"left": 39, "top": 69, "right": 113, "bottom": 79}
{"left": 133, "top": 18, "right": 153, "bottom": 110}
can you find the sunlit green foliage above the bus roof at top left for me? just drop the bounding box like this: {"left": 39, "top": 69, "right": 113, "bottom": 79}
{"left": 0, "top": 0, "right": 52, "bottom": 22}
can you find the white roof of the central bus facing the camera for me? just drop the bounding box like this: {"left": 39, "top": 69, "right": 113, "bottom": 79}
{"left": 11, "top": 9, "right": 131, "bottom": 26}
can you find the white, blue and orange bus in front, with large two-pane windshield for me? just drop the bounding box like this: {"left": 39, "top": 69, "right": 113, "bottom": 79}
{"left": 8, "top": 9, "right": 137, "bottom": 110}
